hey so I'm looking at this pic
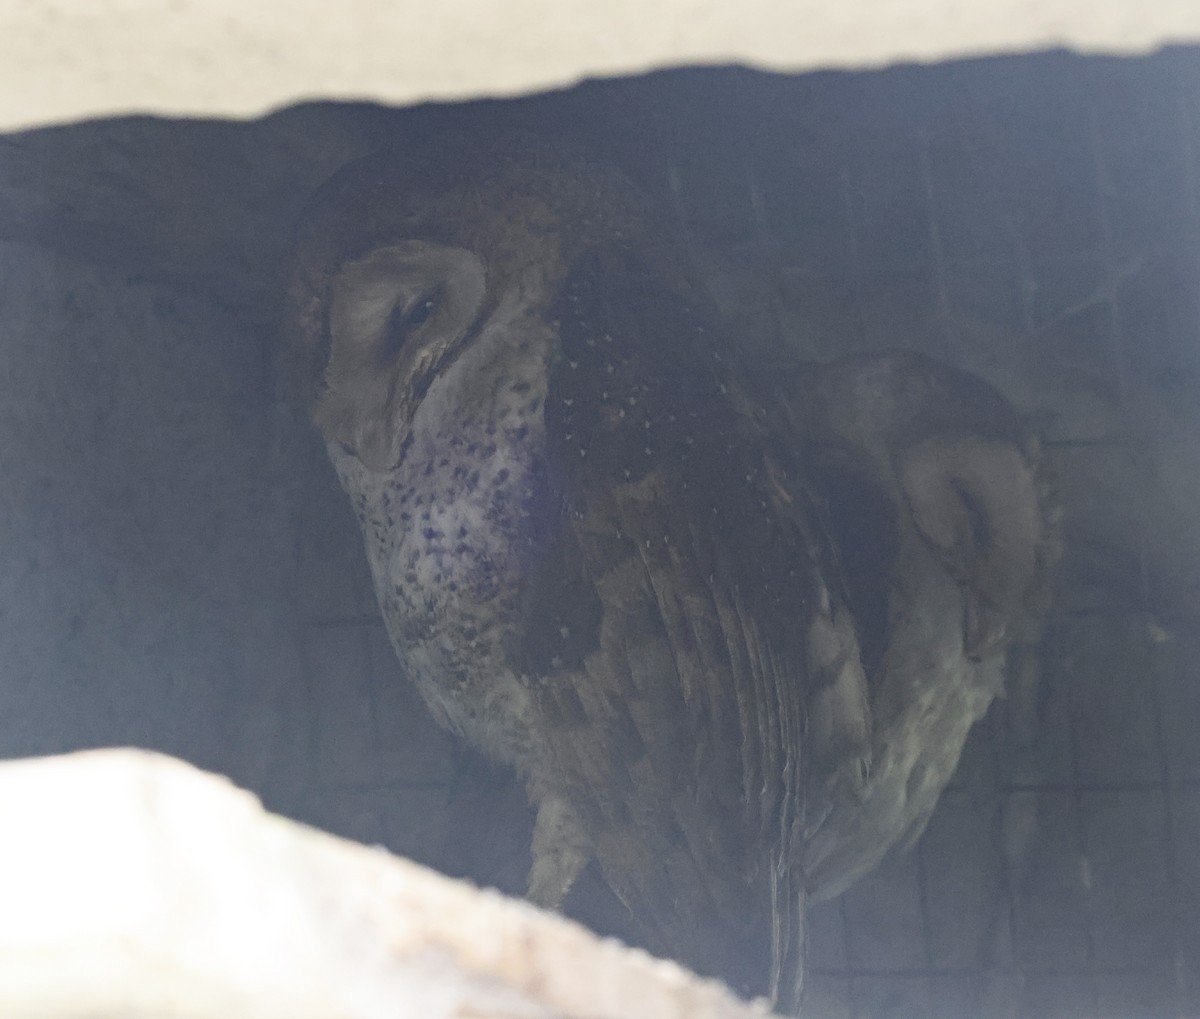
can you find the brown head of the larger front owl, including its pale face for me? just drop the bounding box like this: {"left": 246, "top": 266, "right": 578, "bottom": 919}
{"left": 286, "top": 134, "right": 684, "bottom": 469}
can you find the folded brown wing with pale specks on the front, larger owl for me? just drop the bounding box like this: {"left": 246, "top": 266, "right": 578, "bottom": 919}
{"left": 511, "top": 251, "right": 869, "bottom": 990}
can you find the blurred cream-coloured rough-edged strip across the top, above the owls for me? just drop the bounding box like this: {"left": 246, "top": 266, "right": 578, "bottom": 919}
{"left": 7, "top": 0, "right": 1200, "bottom": 130}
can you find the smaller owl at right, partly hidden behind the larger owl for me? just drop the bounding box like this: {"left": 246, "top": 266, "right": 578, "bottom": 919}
{"left": 779, "top": 352, "right": 1061, "bottom": 898}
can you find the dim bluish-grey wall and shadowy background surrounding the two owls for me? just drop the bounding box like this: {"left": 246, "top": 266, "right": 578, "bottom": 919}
{"left": 0, "top": 50, "right": 1200, "bottom": 1017}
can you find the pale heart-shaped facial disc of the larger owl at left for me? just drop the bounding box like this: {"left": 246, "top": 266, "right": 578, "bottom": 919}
{"left": 314, "top": 240, "right": 486, "bottom": 470}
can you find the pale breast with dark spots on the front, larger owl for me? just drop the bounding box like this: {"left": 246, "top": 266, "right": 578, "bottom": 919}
{"left": 329, "top": 319, "right": 556, "bottom": 757}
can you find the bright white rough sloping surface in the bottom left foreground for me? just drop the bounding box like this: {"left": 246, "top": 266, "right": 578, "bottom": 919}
{"left": 0, "top": 750, "right": 764, "bottom": 1019}
